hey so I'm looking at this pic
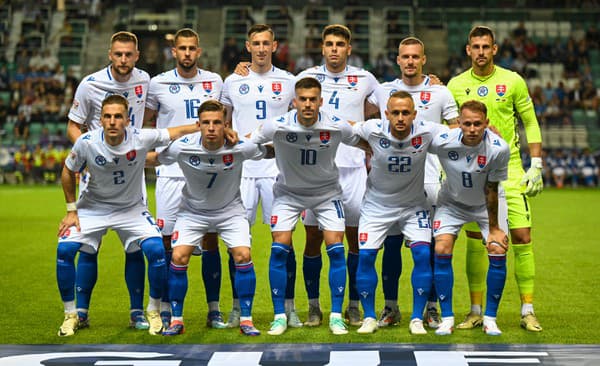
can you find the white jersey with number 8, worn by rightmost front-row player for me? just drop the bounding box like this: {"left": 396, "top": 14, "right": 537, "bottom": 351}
{"left": 430, "top": 128, "right": 510, "bottom": 207}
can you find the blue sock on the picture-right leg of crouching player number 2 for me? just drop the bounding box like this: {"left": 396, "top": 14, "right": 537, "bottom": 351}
{"left": 140, "top": 237, "right": 167, "bottom": 299}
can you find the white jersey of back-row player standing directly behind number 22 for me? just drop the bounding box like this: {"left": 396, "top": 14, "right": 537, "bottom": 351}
{"left": 369, "top": 76, "right": 458, "bottom": 183}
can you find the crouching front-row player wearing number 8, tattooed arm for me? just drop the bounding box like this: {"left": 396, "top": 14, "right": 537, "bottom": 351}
{"left": 430, "top": 100, "right": 510, "bottom": 335}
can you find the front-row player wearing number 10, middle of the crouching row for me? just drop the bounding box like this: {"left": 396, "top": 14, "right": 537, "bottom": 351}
{"left": 252, "top": 77, "right": 364, "bottom": 335}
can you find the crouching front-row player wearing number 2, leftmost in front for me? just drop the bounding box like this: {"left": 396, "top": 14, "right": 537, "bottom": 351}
{"left": 56, "top": 95, "right": 203, "bottom": 337}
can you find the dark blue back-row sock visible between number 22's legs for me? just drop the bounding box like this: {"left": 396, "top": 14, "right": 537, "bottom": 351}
{"left": 381, "top": 235, "right": 404, "bottom": 301}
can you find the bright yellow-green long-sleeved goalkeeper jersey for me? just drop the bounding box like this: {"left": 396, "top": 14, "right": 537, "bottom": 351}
{"left": 448, "top": 65, "right": 542, "bottom": 161}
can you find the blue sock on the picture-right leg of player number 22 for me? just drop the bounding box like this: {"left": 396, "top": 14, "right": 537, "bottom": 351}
{"left": 410, "top": 241, "right": 433, "bottom": 319}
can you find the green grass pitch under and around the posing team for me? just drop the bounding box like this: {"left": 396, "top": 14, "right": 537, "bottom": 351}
{"left": 0, "top": 186, "right": 600, "bottom": 344}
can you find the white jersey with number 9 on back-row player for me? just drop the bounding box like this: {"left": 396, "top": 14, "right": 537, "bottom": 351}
{"left": 221, "top": 66, "right": 296, "bottom": 178}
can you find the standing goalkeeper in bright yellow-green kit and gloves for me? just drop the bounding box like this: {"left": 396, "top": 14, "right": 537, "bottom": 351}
{"left": 448, "top": 26, "right": 544, "bottom": 332}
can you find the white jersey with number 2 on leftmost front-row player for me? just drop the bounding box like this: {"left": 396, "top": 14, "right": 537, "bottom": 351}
{"left": 65, "top": 127, "right": 170, "bottom": 212}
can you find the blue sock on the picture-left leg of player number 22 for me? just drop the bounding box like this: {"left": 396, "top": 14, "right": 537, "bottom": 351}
{"left": 356, "top": 249, "right": 377, "bottom": 318}
